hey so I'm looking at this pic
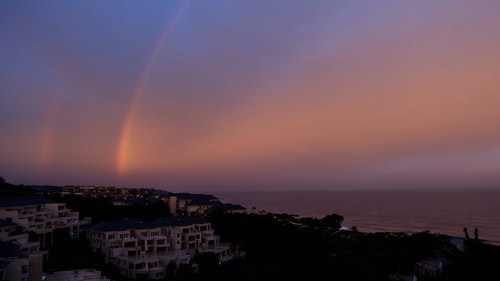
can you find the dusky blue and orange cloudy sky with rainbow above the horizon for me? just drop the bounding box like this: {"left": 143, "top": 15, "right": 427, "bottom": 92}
{"left": 0, "top": 0, "right": 500, "bottom": 191}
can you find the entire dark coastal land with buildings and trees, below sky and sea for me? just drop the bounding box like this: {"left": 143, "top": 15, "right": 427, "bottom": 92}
{"left": 0, "top": 178, "right": 500, "bottom": 281}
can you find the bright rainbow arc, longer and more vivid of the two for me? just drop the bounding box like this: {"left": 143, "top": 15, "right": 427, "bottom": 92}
{"left": 116, "top": 1, "right": 190, "bottom": 174}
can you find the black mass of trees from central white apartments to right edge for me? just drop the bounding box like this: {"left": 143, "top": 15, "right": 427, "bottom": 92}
{"left": 197, "top": 213, "right": 500, "bottom": 281}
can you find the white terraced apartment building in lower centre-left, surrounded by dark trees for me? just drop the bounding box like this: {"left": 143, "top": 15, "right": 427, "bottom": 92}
{"left": 87, "top": 217, "right": 244, "bottom": 279}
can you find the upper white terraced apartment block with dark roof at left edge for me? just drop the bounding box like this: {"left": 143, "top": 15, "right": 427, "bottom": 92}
{"left": 0, "top": 197, "right": 91, "bottom": 247}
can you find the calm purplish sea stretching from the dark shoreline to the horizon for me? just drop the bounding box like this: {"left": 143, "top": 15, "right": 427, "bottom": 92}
{"left": 212, "top": 189, "right": 500, "bottom": 245}
